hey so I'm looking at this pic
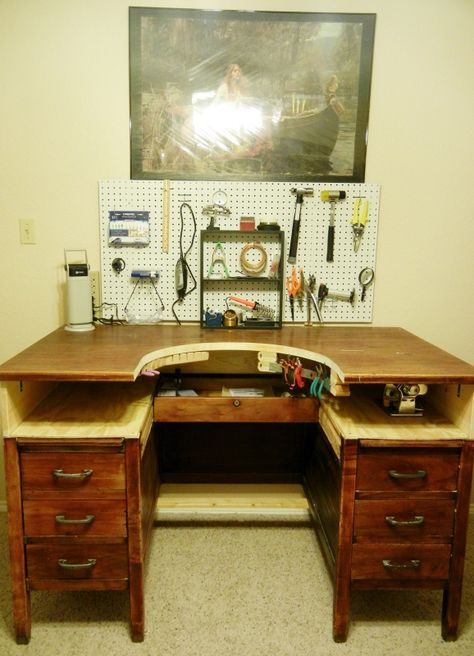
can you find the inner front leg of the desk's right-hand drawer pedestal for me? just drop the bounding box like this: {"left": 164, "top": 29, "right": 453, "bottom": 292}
{"left": 333, "top": 440, "right": 357, "bottom": 642}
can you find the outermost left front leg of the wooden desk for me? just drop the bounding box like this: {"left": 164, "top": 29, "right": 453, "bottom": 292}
{"left": 4, "top": 437, "right": 31, "bottom": 644}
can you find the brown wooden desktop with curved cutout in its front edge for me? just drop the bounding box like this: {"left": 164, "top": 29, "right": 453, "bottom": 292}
{"left": 0, "top": 324, "right": 474, "bottom": 384}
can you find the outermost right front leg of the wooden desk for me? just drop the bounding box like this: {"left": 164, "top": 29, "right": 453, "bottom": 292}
{"left": 441, "top": 443, "right": 474, "bottom": 640}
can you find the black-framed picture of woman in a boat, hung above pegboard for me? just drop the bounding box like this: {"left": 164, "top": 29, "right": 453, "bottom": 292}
{"left": 129, "top": 7, "right": 375, "bottom": 182}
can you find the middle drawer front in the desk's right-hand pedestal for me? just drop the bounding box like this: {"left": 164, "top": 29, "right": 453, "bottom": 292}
{"left": 354, "top": 499, "right": 454, "bottom": 542}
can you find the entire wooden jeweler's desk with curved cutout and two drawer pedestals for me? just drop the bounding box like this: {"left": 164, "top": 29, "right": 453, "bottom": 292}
{"left": 0, "top": 325, "right": 474, "bottom": 642}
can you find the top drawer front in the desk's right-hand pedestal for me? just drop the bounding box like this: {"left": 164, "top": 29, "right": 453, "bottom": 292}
{"left": 356, "top": 448, "right": 459, "bottom": 492}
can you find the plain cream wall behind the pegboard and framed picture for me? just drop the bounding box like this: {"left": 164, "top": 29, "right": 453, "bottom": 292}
{"left": 0, "top": 0, "right": 474, "bottom": 494}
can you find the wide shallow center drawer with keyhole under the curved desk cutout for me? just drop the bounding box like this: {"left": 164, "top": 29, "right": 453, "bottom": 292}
{"left": 154, "top": 396, "right": 318, "bottom": 423}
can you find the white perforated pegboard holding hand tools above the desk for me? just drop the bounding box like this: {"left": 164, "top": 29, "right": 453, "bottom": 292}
{"left": 99, "top": 180, "right": 380, "bottom": 323}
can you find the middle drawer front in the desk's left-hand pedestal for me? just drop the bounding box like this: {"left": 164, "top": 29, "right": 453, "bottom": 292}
{"left": 23, "top": 495, "right": 127, "bottom": 538}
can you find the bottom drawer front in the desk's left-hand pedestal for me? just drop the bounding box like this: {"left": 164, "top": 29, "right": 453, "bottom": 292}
{"left": 26, "top": 543, "right": 128, "bottom": 580}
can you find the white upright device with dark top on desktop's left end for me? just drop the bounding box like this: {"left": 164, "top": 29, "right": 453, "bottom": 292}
{"left": 65, "top": 263, "right": 95, "bottom": 332}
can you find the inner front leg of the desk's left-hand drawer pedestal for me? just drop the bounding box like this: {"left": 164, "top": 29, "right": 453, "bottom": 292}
{"left": 125, "top": 439, "right": 145, "bottom": 642}
